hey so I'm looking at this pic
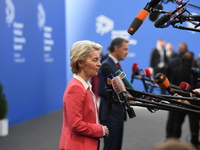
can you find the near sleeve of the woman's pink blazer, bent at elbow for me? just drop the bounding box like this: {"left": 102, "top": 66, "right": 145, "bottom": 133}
{"left": 64, "top": 85, "right": 103, "bottom": 138}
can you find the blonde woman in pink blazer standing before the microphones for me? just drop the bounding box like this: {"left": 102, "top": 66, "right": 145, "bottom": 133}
{"left": 59, "top": 40, "right": 109, "bottom": 150}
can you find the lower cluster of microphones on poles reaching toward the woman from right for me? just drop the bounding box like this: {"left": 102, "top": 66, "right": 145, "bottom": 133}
{"left": 102, "top": 63, "right": 200, "bottom": 118}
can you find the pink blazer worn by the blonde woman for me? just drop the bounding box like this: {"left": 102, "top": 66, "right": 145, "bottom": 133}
{"left": 59, "top": 78, "right": 103, "bottom": 150}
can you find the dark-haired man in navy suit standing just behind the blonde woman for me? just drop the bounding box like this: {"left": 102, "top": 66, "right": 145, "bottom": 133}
{"left": 98, "top": 37, "right": 129, "bottom": 150}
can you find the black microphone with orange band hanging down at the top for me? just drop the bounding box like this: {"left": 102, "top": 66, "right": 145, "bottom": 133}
{"left": 127, "top": 0, "right": 161, "bottom": 35}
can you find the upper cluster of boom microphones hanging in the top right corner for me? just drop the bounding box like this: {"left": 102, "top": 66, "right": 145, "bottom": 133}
{"left": 127, "top": 0, "right": 200, "bottom": 35}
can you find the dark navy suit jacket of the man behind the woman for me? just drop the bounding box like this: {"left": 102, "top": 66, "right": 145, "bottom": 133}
{"left": 98, "top": 57, "right": 126, "bottom": 122}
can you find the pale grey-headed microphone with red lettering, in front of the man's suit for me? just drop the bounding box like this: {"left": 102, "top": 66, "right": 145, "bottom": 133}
{"left": 112, "top": 76, "right": 136, "bottom": 118}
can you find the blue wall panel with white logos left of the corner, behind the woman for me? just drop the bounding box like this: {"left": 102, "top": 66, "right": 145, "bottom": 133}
{"left": 0, "top": 0, "right": 66, "bottom": 125}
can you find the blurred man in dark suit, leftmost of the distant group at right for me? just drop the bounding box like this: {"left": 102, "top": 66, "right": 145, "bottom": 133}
{"left": 150, "top": 39, "right": 167, "bottom": 94}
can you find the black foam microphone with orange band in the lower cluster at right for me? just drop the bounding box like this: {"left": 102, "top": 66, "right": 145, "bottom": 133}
{"left": 154, "top": 73, "right": 175, "bottom": 95}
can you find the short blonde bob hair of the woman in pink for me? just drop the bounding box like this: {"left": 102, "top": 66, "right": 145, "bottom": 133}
{"left": 70, "top": 40, "right": 102, "bottom": 73}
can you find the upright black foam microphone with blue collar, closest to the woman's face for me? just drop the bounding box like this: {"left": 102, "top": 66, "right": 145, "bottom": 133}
{"left": 102, "top": 67, "right": 114, "bottom": 116}
